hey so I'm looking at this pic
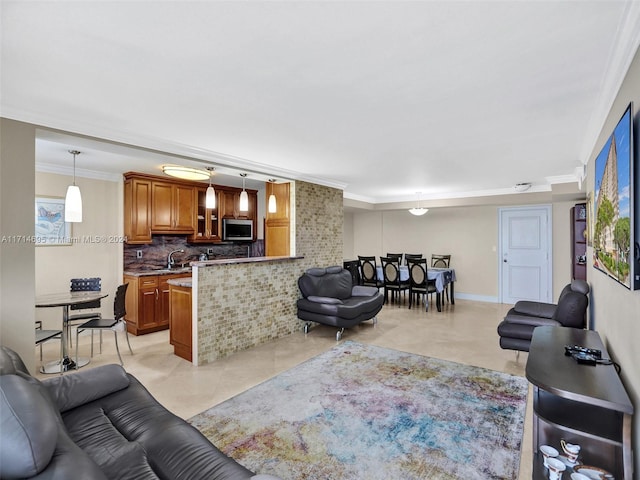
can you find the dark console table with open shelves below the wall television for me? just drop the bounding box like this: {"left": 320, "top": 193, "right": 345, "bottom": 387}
{"left": 526, "top": 327, "right": 633, "bottom": 480}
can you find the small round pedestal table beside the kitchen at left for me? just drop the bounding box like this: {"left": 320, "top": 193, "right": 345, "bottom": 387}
{"left": 36, "top": 291, "right": 109, "bottom": 373}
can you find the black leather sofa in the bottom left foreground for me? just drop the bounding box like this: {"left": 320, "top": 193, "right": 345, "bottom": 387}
{"left": 0, "top": 347, "right": 277, "bottom": 480}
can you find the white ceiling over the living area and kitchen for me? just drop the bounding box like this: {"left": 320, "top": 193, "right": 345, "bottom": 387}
{"left": 0, "top": 0, "right": 640, "bottom": 203}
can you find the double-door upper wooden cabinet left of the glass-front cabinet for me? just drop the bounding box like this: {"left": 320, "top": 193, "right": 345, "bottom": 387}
{"left": 151, "top": 181, "right": 196, "bottom": 233}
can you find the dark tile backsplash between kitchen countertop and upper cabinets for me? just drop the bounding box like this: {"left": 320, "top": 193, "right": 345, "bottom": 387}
{"left": 124, "top": 235, "right": 264, "bottom": 270}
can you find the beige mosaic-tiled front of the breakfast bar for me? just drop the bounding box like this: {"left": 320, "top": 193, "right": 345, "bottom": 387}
{"left": 191, "top": 256, "right": 304, "bottom": 365}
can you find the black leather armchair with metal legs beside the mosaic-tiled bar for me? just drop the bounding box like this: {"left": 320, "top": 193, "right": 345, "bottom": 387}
{"left": 297, "top": 266, "right": 384, "bottom": 340}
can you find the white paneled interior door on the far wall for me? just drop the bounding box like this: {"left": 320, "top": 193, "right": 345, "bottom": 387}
{"left": 500, "top": 206, "right": 552, "bottom": 303}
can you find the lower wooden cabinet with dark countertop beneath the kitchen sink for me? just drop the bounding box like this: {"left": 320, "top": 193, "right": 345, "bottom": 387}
{"left": 124, "top": 273, "right": 191, "bottom": 335}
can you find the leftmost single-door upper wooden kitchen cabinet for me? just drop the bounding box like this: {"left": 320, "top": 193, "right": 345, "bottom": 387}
{"left": 124, "top": 176, "right": 151, "bottom": 244}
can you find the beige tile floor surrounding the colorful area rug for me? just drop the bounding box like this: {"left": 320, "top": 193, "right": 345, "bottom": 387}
{"left": 36, "top": 300, "right": 532, "bottom": 480}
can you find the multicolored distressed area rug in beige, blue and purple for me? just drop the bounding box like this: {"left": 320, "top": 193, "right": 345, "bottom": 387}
{"left": 189, "top": 341, "right": 528, "bottom": 480}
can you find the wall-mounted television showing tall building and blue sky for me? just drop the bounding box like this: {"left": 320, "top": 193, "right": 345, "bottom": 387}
{"left": 592, "top": 104, "right": 640, "bottom": 290}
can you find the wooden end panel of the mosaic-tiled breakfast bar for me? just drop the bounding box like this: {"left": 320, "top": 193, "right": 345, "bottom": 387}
{"left": 169, "top": 285, "right": 193, "bottom": 362}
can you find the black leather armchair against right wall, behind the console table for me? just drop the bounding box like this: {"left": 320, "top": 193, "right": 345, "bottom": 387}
{"left": 498, "top": 280, "right": 589, "bottom": 352}
